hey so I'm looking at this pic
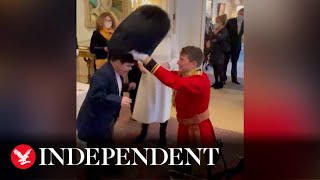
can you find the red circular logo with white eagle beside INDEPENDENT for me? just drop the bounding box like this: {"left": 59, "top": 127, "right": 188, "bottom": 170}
{"left": 11, "top": 144, "right": 36, "bottom": 169}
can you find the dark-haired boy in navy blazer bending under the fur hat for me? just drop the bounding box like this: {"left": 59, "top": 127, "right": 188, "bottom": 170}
{"left": 77, "top": 54, "right": 136, "bottom": 147}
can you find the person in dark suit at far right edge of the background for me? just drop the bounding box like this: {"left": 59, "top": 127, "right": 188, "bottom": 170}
{"left": 224, "top": 8, "right": 244, "bottom": 84}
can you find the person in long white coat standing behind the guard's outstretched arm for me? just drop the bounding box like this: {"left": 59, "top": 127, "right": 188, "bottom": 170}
{"left": 132, "top": 34, "right": 179, "bottom": 147}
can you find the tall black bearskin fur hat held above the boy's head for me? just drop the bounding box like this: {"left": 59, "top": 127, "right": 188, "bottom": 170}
{"left": 108, "top": 5, "right": 170, "bottom": 56}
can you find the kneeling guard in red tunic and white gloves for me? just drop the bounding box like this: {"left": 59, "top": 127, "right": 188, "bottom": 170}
{"left": 130, "top": 46, "right": 216, "bottom": 178}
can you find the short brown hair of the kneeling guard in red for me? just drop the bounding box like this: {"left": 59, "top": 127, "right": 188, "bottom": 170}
{"left": 180, "top": 46, "right": 204, "bottom": 67}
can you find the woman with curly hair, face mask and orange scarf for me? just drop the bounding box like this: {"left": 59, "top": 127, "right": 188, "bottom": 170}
{"left": 90, "top": 12, "right": 116, "bottom": 70}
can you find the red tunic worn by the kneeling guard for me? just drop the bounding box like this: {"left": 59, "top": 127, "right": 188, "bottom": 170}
{"left": 153, "top": 66, "right": 216, "bottom": 148}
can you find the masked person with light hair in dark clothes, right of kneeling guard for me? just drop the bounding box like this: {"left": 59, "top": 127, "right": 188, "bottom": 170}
{"left": 206, "top": 14, "right": 231, "bottom": 89}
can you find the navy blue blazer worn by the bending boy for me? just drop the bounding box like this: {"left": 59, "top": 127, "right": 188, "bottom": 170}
{"left": 77, "top": 62, "right": 128, "bottom": 142}
